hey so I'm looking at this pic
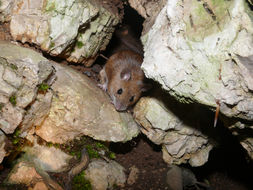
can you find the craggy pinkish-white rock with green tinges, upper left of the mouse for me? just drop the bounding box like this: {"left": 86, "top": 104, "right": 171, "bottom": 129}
{"left": 10, "top": 0, "right": 121, "bottom": 66}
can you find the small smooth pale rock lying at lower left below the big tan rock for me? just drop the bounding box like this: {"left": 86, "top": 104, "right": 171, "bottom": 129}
{"left": 23, "top": 143, "right": 72, "bottom": 173}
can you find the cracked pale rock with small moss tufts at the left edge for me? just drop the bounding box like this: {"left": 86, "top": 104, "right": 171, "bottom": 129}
{"left": 0, "top": 41, "right": 53, "bottom": 134}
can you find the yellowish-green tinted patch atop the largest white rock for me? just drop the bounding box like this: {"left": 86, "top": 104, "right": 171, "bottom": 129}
{"left": 184, "top": 0, "right": 233, "bottom": 41}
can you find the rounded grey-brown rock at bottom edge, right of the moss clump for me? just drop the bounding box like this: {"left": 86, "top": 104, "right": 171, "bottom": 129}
{"left": 85, "top": 159, "right": 126, "bottom": 190}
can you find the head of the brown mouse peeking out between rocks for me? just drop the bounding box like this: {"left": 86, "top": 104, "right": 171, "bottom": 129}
{"left": 108, "top": 69, "right": 149, "bottom": 111}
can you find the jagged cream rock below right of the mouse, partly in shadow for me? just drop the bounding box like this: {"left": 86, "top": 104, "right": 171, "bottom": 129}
{"left": 134, "top": 92, "right": 213, "bottom": 166}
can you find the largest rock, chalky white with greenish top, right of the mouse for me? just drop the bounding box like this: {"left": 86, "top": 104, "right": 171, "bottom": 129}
{"left": 142, "top": 0, "right": 253, "bottom": 121}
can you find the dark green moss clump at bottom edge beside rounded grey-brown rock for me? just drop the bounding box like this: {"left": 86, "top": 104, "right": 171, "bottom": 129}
{"left": 72, "top": 171, "right": 92, "bottom": 190}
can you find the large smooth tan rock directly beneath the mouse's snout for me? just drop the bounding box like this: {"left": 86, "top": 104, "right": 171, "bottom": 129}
{"left": 36, "top": 64, "right": 139, "bottom": 143}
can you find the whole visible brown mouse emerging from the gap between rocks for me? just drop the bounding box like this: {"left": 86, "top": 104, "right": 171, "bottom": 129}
{"left": 99, "top": 50, "right": 151, "bottom": 111}
